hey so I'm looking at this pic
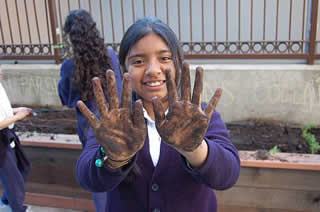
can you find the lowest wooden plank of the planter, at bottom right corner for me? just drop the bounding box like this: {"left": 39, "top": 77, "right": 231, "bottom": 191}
{"left": 216, "top": 186, "right": 320, "bottom": 212}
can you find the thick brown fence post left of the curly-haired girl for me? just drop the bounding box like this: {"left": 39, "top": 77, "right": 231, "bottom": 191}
{"left": 48, "top": 0, "right": 60, "bottom": 63}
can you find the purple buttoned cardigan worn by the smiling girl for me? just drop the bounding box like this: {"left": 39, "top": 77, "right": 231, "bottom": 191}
{"left": 77, "top": 112, "right": 240, "bottom": 212}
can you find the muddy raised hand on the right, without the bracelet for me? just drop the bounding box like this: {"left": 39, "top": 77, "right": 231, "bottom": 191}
{"left": 152, "top": 63, "right": 222, "bottom": 152}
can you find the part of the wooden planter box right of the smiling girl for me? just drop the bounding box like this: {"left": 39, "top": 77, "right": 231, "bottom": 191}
{"left": 217, "top": 151, "right": 320, "bottom": 212}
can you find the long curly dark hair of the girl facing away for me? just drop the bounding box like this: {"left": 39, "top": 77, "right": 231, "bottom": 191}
{"left": 63, "top": 9, "right": 112, "bottom": 101}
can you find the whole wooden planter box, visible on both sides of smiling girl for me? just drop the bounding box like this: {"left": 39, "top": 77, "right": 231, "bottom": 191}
{"left": 1, "top": 134, "right": 320, "bottom": 212}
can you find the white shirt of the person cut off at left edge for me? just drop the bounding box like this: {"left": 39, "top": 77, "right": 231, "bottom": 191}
{"left": 0, "top": 82, "right": 14, "bottom": 130}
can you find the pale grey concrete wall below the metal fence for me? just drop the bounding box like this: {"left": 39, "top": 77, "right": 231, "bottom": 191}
{"left": 1, "top": 64, "right": 320, "bottom": 125}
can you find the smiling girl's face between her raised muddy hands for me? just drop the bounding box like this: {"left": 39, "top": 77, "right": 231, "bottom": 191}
{"left": 125, "top": 33, "right": 175, "bottom": 104}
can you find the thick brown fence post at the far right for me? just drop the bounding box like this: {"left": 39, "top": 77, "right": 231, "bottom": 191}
{"left": 308, "top": 0, "right": 318, "bottom": 65}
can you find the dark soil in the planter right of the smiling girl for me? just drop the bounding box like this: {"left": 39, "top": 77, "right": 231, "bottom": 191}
{"left": 227, "top": 120, "right": 320, "bottom": 154}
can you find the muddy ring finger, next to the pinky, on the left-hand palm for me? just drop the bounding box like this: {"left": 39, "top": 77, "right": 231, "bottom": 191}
{"left": 92, "top": 77, "right": 108, "bottom": 119}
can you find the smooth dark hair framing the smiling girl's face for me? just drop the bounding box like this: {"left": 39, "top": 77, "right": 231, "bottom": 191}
{"left": 119, "top": 17, "right": 183, "bottom": 86}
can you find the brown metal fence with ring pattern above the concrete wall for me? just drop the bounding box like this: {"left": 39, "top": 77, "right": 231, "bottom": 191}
{"left": 0, "top": 0, "right": 320, "bottom": 64}
